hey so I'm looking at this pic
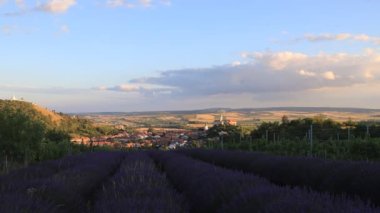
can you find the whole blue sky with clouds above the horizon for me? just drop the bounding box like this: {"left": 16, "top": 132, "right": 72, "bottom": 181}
{"left": 0, "top": 0, "right": 380, "bottom": 113}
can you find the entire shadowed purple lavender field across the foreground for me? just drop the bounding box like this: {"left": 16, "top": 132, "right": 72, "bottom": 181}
{"left": 0, "top": 150, "right": 380, "bottom": 212}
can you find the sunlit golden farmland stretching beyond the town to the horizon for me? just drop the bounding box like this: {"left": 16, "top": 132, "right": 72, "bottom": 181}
{"left": 79, "top": 107, "right": 380, "bottom": 128}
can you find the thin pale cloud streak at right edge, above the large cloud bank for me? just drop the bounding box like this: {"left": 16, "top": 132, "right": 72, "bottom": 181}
{"left": 297, "top": 33, "right": 380, "bottom": 45}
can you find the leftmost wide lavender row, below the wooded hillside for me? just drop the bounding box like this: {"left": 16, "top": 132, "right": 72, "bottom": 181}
{"left": 0, "top": 152, "right": 125, "bottom": 212}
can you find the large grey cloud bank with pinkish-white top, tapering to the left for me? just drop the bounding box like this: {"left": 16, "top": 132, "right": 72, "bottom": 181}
{"left": 102, "top": 51, "right": 380, "bottom": 97}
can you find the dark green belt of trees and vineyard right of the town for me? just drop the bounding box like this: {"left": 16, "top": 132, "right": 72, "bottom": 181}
{"left": 205, "top": 115, "right": 380, "bottom": 160}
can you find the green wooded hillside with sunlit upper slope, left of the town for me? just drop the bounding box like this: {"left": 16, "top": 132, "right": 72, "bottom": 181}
{"left": 0, "top": 100, "right": 112, "bottom": 166}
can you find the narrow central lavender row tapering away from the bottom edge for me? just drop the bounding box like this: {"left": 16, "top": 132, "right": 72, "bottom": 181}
{"left": 94, "top": 152, "right": 188, "bottom": 213}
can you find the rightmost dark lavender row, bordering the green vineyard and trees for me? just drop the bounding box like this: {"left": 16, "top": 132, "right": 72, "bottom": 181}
{"left": 181, "top": 150, "right": 380, "bottom": 205}
